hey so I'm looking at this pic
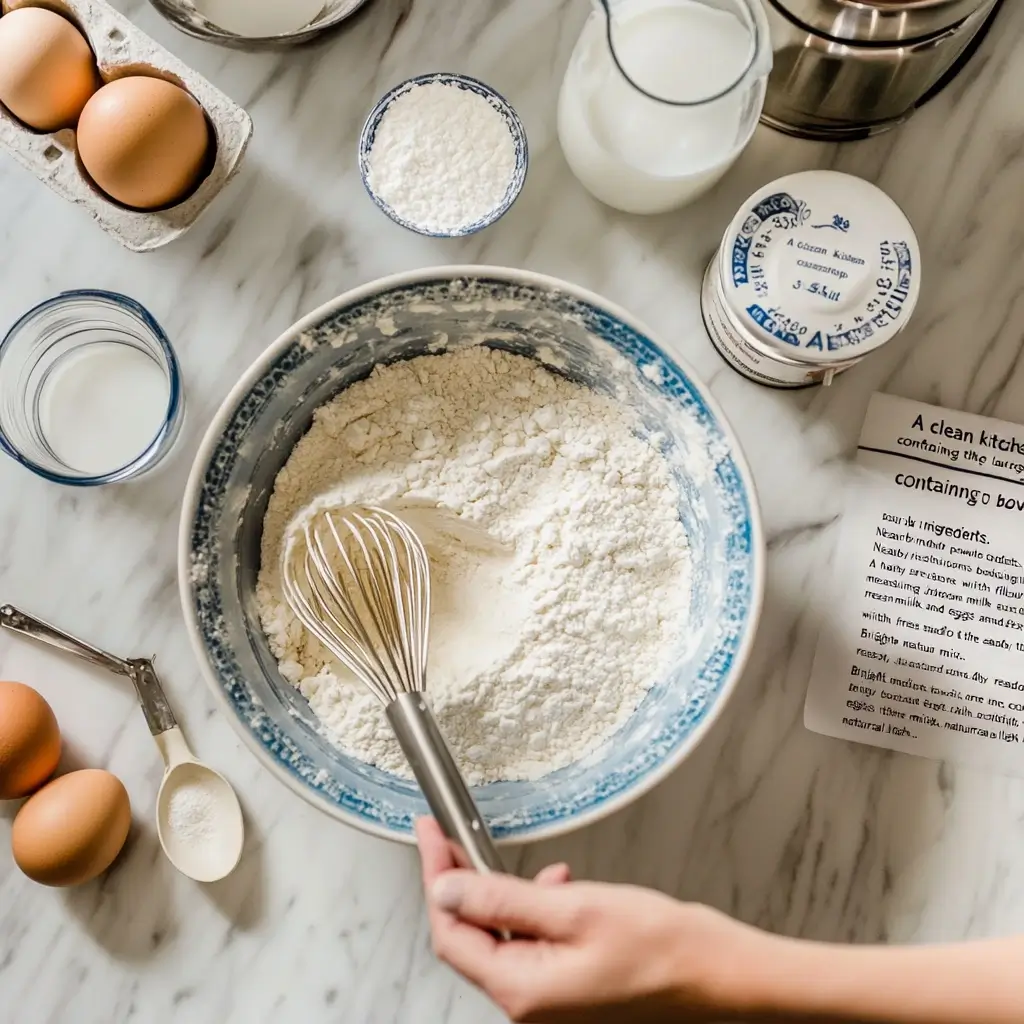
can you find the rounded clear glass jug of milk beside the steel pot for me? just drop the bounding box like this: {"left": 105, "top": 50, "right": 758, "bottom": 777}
{"left": 558, "top": 0, "right": 772, "bottom": 213}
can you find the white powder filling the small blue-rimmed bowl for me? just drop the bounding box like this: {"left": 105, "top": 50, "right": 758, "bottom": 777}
{"left": 367, "top": 82, "right": 516, "bottom": 233}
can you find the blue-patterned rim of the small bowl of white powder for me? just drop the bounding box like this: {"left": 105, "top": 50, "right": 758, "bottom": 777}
{"left": 359, "top": 72, "right": 529, "bottom": 239}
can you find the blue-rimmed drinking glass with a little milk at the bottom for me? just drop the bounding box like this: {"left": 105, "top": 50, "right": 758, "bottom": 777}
{"left": 0, "top": 291, "right": 184, "bottom": 486}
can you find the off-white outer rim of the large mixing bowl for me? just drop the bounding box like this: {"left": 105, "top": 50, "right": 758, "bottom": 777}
{"left": 177, "top": 264, "right": 767, "bottom": 846}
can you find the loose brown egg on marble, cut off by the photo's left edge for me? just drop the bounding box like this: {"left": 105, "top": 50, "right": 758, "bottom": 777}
{"left": 0, "top": 682, "right": 60, "bottom": 800}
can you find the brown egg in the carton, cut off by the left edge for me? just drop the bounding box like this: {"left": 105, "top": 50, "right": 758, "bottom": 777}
{"left": 0, "top": 7, "right": 99, "bottom": 131}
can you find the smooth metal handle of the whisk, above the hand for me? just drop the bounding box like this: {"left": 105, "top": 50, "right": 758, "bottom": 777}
{"left": 386, "top": 693, "right": 505, "bottom": 874}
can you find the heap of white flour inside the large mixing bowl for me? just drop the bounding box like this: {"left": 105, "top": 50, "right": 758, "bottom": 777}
{"left": 257, "top": 347, "right": 691, "bottom": 784}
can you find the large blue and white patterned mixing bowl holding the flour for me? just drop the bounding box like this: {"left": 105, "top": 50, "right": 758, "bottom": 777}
{"left": 179, "top": 267, "right": 764, "bottom": 841}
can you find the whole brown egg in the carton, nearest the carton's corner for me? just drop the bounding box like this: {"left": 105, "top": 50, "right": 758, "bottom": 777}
{"left": 78, "top": 77, "right": 210, "bottom": 210}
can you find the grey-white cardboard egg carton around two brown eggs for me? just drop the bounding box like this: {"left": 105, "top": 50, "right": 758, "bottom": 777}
{"left": 0, "top": 0, "right": 253, "bottom": 252}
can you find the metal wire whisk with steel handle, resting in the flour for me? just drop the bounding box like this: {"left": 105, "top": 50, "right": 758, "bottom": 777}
{"left": 282, "top": 506, "right": 503, "bottom": 871}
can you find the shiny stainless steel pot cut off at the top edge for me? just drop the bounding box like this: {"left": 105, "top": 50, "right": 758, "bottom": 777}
{"left": 762, "top": 0, "right": 999, "bottom": 139}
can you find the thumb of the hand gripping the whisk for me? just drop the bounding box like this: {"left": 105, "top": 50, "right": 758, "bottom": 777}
{"left": 430, "top": 871, "right": 574, "bottom": 939}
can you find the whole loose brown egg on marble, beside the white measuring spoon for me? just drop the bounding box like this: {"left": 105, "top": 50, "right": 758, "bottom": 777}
{"left": 10, "top": 768, "right": 131, "bottom": 886}
